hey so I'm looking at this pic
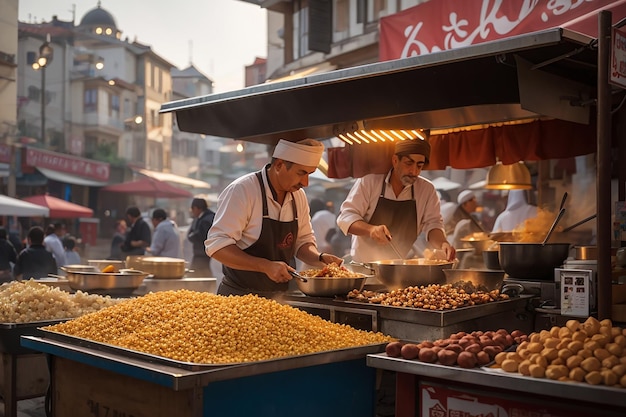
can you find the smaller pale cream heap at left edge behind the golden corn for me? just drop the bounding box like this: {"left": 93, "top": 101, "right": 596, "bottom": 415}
{"left": 0, "top": 279, "right": 119, "bottom": 323}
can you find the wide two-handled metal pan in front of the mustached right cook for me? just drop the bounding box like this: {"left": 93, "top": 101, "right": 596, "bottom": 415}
{"left": 354, "top": 258, "right": 455, "bottom": 290}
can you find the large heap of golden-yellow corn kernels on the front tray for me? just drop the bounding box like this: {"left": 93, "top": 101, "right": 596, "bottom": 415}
{"left": 46, "top": 290, "right": 394, "bottom": 364}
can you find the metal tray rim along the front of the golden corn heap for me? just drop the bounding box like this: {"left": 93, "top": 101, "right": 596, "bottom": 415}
{"left": 40, "top": 329, "right": 387, "bottom": 372}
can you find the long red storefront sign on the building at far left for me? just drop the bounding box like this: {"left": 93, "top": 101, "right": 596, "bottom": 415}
{"left": 26, "top": 148, "right": 110, "bottom": 181}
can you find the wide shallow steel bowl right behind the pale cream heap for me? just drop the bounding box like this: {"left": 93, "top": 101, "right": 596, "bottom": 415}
{"left": 66, "top": 270, "right": 150, "bottom": 291}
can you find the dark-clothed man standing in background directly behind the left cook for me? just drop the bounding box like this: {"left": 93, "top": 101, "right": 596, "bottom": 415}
{"left": 187, "top": 198, "right": 215, "bottom": 277}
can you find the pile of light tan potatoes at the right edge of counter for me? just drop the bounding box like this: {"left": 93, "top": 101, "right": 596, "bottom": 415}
{"left": 493, "top": 317, "right": 626, "bottom": 388}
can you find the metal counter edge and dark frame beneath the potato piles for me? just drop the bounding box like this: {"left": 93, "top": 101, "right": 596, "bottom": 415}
{"left": 367, "top": 353, "right": 626, "bottom": 417}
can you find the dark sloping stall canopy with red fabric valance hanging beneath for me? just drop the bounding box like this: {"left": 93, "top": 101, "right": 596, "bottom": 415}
{"left": 161, "top": 13, "right": 626, "bottom": 178}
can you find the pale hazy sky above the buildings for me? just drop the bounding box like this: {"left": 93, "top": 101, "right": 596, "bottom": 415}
{"left": 18, "top": 0, "right": 267, "bottom": 93}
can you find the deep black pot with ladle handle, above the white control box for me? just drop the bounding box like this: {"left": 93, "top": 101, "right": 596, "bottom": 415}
{"left": 499, "top": 242, "right": 570, "bottom": 281}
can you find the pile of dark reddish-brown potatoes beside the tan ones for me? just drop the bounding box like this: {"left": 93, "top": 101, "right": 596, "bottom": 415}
{"left": 385, "top": 329, "right": 528, "bottom": 368}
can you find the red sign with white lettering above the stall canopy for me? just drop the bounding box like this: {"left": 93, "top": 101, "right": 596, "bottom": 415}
{"left": 380, "top": 0, "right": 626, "bottom": 61}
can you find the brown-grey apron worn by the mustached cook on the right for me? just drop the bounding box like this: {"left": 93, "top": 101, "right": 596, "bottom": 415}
{"left": 363, "top": 180, "right": 417, "bottom": 261}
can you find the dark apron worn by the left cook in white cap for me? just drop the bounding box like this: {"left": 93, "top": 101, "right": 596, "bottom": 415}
{"left": 217, "top": 172, "right": 298, "bottom": 298}
